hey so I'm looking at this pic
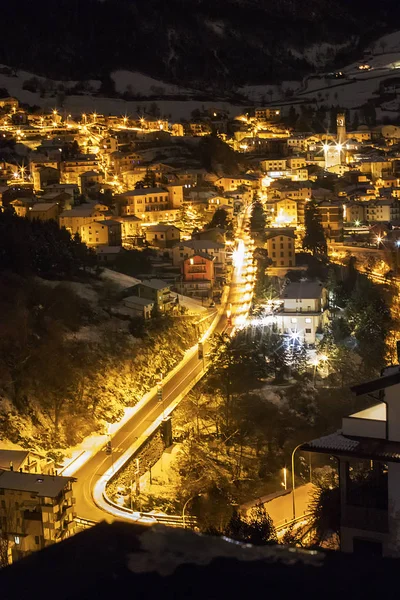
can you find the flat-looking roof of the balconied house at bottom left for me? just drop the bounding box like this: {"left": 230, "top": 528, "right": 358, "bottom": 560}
{"left": 0, "top": 471, "right": 76, "bottom": 498}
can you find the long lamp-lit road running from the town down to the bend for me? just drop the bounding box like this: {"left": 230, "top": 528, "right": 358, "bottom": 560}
{"left": 74, "top": 216, "right": 254, "bottom": 521}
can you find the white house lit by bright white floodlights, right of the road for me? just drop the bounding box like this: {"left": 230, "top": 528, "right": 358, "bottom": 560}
{"left": 274, "top": 281, "right": 327, "bottom": 344}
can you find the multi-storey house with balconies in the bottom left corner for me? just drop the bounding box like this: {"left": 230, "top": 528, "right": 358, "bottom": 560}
{"left": 0, "top": 470, "right": 76, "bottom": 562}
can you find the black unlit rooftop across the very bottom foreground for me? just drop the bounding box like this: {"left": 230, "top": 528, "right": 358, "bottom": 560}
{"left": 0, "top": 523, "right": 400, "bottom": 600}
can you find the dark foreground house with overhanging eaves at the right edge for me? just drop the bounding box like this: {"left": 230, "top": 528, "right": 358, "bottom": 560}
{"left": 301, "top": 365, "right": 400, "bottom": 557}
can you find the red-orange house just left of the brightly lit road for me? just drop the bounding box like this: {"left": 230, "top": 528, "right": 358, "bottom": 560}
{"left": 176, "top": 252, "right": 215, "bottom": 298}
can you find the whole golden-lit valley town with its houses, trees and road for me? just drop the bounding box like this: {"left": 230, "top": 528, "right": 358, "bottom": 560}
{"left": 0, "top": 82, "right": 400, "bottom": 564}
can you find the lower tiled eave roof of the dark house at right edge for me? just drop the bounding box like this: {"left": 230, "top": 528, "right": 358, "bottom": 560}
{"left": 301, "top": 431, "right": 400, "bottom": 462}
